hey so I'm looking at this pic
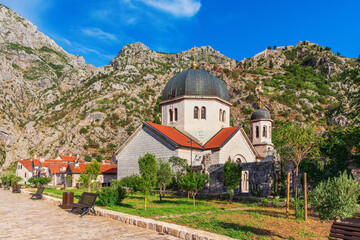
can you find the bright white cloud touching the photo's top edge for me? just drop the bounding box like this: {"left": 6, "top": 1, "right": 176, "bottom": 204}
{"left": 139, "top": 0, "right": 201, "bottom": 17}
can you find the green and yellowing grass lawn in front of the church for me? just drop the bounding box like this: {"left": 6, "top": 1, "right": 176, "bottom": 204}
{"left": 34, "top": 188, "right": 331, "bottom": 239}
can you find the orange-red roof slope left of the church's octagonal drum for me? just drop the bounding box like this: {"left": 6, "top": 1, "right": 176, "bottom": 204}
{"left": 146, "top": 122, "right": 203, "bottom": 149}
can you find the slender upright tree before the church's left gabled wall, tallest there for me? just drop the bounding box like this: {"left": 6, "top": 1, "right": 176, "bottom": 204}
{"left": 138, "top": 153, "right": 157, "bottom": 211}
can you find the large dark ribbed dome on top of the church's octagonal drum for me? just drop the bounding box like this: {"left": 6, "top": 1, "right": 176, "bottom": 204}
{"left": 162, "top": 69, "right": 230, "bottom": 102}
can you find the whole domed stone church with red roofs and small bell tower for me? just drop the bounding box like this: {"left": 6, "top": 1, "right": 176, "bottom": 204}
{"left": 113, "top": 64, "right": 273, "bottom": 195}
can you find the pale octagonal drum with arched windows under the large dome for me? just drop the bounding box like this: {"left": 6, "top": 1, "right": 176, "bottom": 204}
{"left": 161, "top": 98, "right": 230, "bottom": 143}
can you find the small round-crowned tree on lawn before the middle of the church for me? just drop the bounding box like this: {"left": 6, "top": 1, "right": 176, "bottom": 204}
{"left": 179, "top": 168, "right": 210, "bottom": 207}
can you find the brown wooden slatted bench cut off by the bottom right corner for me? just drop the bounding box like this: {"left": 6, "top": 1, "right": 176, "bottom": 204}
{"left": 329, "top": 221, "right": 360, "bottom": 240}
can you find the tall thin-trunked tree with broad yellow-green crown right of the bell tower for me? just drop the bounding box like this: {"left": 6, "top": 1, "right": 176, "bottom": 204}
{"left": 273, "top": 122, "right": 322, "bottom": 211}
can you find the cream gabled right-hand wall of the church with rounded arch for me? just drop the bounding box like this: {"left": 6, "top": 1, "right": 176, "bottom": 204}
{"left": 211, "top": 131, "right": 256, "bottom": 164}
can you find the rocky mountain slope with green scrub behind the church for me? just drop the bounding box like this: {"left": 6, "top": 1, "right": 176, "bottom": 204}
{"left": 0, "top": 5, "right": 359, "bottom": 167}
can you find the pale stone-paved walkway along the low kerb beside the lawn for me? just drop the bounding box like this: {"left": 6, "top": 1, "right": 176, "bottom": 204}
{"left": 0, "top": 188, "right": 179, "bottom": 240}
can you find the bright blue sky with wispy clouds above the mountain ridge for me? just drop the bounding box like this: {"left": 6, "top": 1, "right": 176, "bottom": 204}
{"left": 0, "top": 0, "right": 360, "bottom": 66}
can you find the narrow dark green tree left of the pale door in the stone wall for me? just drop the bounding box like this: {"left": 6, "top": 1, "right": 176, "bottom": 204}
{"left": 224, "top": 157, "right": 242, "bottom": 204}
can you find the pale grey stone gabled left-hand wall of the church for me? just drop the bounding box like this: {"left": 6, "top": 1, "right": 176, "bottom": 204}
{"left": 117, "top": 127, "right": 177, "bottom": 179}
